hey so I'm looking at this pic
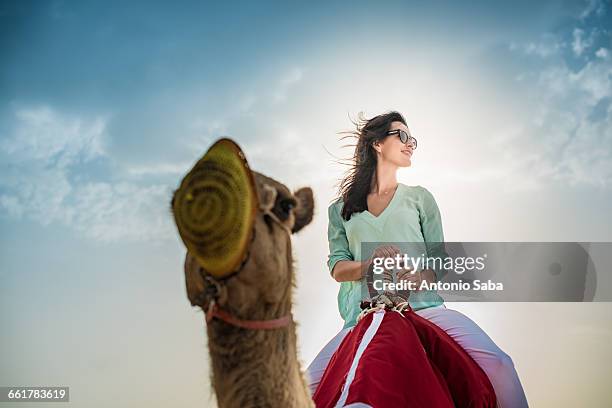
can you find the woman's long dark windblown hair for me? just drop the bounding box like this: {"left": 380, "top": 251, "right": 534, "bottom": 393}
{"left": 337, "top": 111, "right": 407, "bottom": 221}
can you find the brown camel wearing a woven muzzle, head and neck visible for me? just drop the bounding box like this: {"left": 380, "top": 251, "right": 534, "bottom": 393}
{"left": 171, "top": 138, "right": 314, "bottom": 408}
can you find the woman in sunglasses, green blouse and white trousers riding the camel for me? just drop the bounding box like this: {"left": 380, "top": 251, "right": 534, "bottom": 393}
{"left": 307, "top": 112, "right": 528, "bottom": 408}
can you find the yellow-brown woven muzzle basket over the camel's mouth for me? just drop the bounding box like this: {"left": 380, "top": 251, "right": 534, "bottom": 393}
{"left": 172, "top": 138, "right": 258, "bottom": 278}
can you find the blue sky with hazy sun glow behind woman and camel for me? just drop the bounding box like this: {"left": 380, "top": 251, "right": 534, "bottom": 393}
{"left": 0, "top": 1, "right": 612, "bottom": 407}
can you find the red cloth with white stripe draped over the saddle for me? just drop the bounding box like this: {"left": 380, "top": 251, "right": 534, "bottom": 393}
{"left": 313, "top": 310, "right": 497, "bottom": 408}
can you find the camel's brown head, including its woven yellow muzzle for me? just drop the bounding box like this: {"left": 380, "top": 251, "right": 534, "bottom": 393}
{"left": 171, "top": 138, "right": 314, "bottom": 320}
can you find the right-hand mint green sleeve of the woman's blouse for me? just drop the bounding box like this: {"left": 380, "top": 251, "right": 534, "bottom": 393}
{"left": 419, "top": 187, "right": 448, "bottom": 281}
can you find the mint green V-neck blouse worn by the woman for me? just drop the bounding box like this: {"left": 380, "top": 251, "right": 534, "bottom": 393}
{"left": 327, "top": 183, "right": 446, "bottom": 328}
